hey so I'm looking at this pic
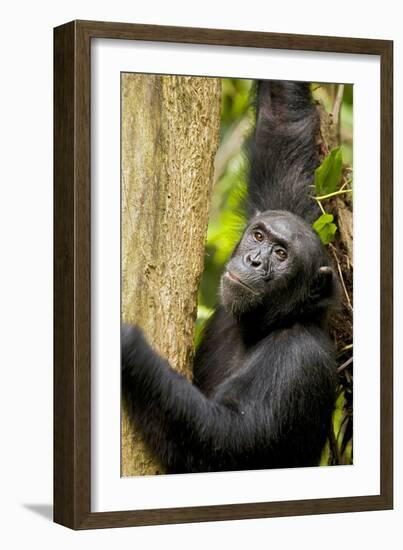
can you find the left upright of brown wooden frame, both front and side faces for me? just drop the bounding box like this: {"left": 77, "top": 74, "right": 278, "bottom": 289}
{"left": 54, "top": 22, "right": 91, "bottom": 528}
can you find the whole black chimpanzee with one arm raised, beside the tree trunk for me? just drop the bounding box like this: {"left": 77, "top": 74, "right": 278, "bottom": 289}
{"left": 122, "top": 81, "right": 337, "bottom": 473}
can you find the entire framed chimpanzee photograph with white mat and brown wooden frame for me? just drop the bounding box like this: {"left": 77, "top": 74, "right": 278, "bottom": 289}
{"left": 54, "top": 21, "right": 393, "bottom": 529}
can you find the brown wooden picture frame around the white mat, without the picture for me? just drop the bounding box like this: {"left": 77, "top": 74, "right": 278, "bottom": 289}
{"left": 54, "top": 21, "right": 393, "bottom": 529}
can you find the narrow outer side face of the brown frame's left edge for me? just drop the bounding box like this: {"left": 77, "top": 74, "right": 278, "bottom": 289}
{"left": 53, "top": 24, "right": 76, "bottom": 525}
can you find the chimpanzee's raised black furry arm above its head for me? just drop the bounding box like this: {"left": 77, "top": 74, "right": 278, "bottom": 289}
{"left": 248, "top": 80, "right": 320, "bottom": 222}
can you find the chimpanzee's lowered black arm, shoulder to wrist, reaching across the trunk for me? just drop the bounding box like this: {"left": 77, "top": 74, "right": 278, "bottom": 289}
{"left": 122, "top": 327, "right": 333, "bottom": 473}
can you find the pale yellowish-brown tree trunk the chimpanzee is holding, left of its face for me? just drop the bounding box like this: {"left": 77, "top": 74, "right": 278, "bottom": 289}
{"left": 121, "top": 74, "right": 220, "bottom": 476}
